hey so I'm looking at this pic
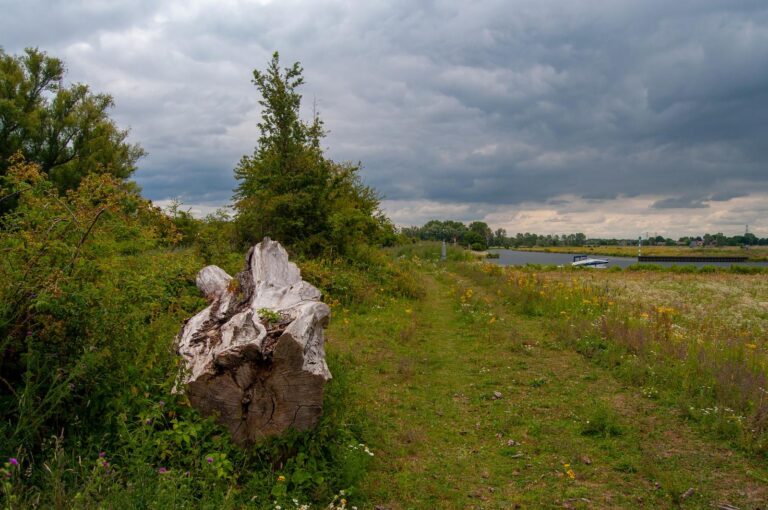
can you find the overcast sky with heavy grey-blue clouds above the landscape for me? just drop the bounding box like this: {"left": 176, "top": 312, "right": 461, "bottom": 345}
{"left": 0, "top": 0, "right": 768, "bottom": 237}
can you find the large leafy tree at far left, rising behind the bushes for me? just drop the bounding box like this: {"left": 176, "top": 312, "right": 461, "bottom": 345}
{"left": 0, "top": 49, "right": 144, "bottom": 192}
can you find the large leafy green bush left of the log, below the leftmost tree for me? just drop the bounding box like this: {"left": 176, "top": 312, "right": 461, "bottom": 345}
{"left": 0, "top": 157, "right": 191, "bottom": 455}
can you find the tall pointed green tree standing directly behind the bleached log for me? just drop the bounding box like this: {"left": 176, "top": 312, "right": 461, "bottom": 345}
{"left": 235, "top": 52, "right": 394, "bottom": 256}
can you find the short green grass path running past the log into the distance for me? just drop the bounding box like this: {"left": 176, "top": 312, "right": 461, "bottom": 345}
{"left": 329, "top": 272, "right": 768, "bottom": 510}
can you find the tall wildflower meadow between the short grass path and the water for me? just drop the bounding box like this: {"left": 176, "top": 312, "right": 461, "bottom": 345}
{"left": 461, "top": 264, "right": 768, "bottom": 455}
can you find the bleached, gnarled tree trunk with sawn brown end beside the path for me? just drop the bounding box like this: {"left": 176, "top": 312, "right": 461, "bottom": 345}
{"left": 176, "top": 237, "right": 331, "bottom": 445}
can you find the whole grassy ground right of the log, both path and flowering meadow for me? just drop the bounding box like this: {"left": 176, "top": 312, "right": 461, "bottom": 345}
{"left": 327, "top": 252, "right": 768, "bottom": 510}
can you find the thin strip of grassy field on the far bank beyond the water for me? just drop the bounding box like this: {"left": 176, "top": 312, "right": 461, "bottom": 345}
{"left": 515, "top": 246, "right": 768, "bottom": 262}
